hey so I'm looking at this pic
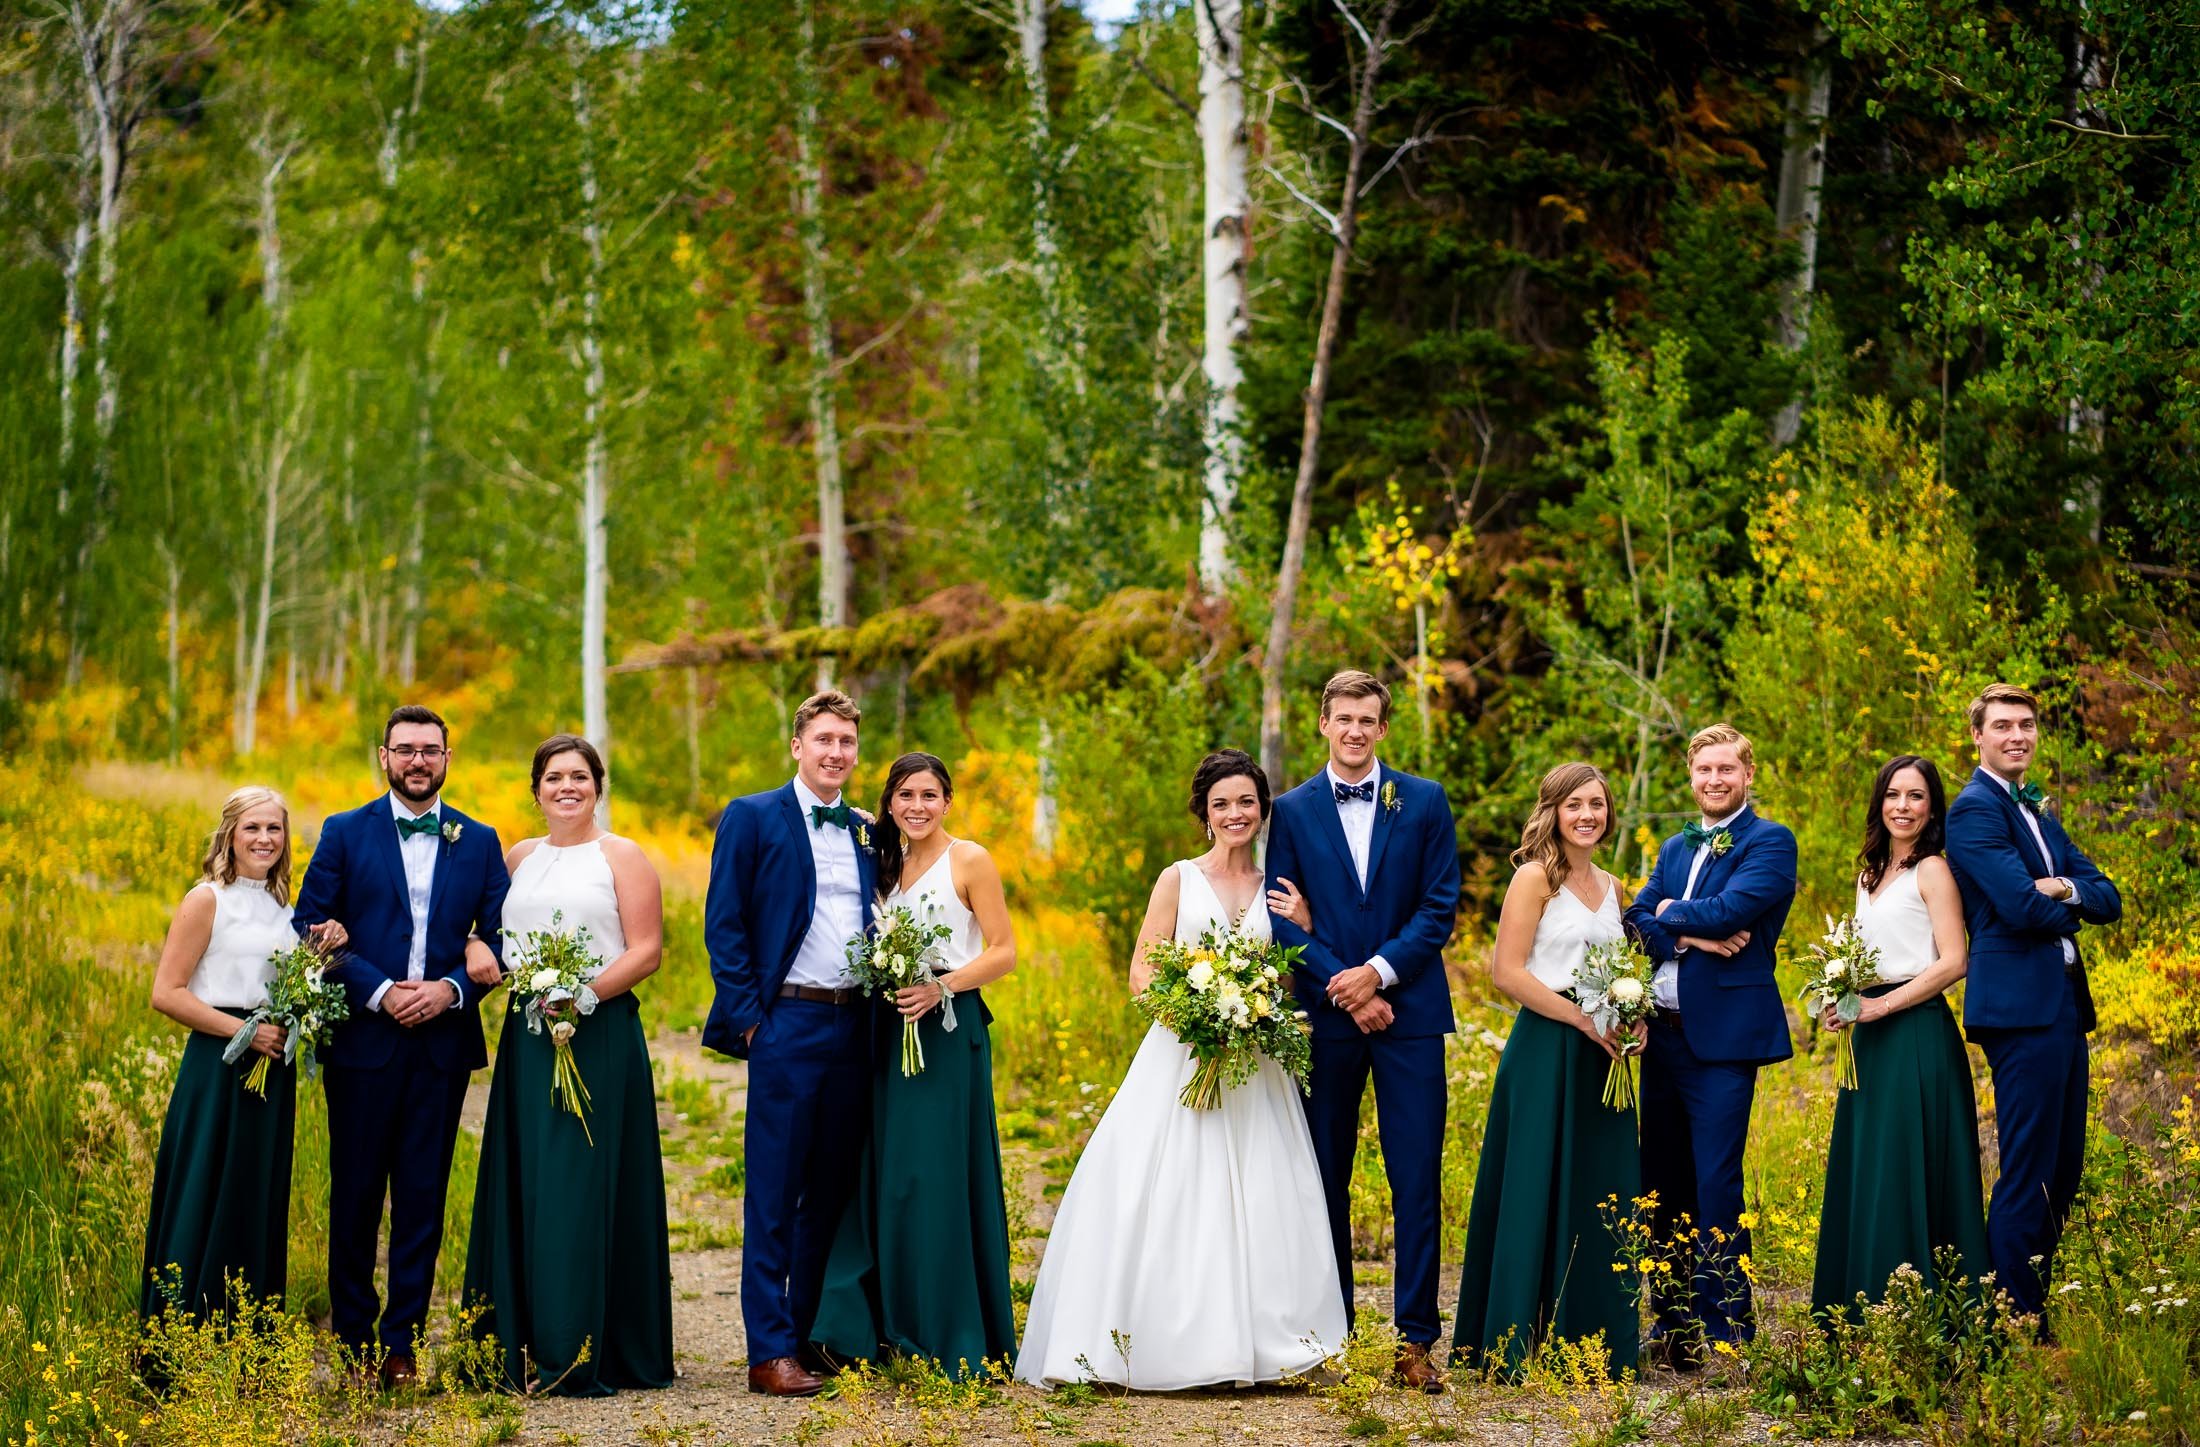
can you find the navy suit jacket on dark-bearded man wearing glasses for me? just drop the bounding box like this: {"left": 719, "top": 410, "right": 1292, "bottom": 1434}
{"left": 290, "top": 794, "right": 513, "bottom": 1071}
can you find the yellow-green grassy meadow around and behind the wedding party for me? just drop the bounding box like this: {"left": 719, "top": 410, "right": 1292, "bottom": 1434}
{"left": 0, "top": 725, "right": 2200, "bottom": 1447}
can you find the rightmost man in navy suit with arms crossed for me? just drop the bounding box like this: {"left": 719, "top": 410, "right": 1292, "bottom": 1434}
{"left": 1947, "top": 684, "right": 2123, "bottom": 1333}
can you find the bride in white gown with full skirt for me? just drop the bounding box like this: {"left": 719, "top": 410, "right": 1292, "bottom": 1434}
{"left": 1016, "top": 748, "right": 1346, "bottom": 1392}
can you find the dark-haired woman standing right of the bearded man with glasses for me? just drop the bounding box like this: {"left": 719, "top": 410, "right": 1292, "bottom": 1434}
{"left": 460, "top": 734, "right": 673, "bottom": 1396}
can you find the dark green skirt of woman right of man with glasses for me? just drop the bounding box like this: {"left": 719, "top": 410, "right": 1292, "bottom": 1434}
{"left": 462, "top": 994, "right": 673, "bottom": 1396}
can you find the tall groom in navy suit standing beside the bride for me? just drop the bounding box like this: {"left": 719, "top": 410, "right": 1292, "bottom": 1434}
{"left": 1267, "top": 671, "right": 1459, "bottom": 1392}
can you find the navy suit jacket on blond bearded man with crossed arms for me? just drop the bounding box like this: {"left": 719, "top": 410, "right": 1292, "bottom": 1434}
{"left": 1628, "top": 805, "right": 1795, "bottom": 1064}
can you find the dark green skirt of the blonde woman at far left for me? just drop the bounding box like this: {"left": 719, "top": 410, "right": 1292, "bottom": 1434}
{"left": 139, "top": 1029, "right": 297, "bottom": 1322}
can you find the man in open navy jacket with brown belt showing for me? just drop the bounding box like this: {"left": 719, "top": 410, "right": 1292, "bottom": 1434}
{"left": 702, "top": 693, "right": 876, "bottom": 1396}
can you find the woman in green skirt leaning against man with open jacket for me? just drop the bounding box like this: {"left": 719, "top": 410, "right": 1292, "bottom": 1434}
{"left": 812, "top": 754, "right": 1016, "bottom": 1379}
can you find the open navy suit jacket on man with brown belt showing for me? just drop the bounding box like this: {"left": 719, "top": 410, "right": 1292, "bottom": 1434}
{"left": 702, "top": 781, "right": 878, "bottom": 1060}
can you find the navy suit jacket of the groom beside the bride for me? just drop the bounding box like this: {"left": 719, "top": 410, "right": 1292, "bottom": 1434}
{"left": 1267, "top": 767, "right": 1459, "bottom": 1038}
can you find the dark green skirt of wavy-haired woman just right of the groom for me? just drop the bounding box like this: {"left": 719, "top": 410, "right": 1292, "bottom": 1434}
{"left": 1452, "top": 1009, "right": 1641, "bottom": 1377}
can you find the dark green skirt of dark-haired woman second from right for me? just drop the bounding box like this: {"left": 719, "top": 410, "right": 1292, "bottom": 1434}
{"left": 1811, "top": 985, "right": 1989, "bottom": 1315}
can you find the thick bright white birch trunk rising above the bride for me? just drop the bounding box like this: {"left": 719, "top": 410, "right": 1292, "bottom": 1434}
{"left": 1192, "top": 0, "right": 1252, "bottom": 596}
